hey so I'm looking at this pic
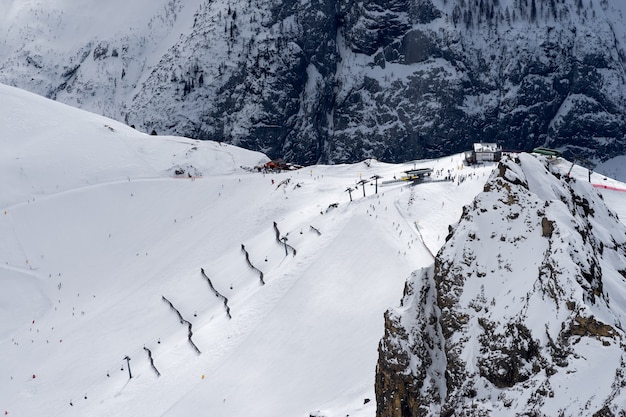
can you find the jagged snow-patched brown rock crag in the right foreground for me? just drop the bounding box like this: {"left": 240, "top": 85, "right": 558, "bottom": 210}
{"left": 376, "top": 154, "right": 626, "bottom": 417}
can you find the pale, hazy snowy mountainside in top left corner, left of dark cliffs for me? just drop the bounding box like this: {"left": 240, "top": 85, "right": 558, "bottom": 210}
{"left": 0, "top": 0, "right": 202, "bottom": 120}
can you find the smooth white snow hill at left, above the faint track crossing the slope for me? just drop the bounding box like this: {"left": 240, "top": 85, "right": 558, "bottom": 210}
{"left": 0, "top": 79, "right": 268, "bottom": 207}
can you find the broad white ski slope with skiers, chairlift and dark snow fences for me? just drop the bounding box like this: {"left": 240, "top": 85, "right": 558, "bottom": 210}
{"left": 0, "top": 82, "right": 626, "bottom": 417}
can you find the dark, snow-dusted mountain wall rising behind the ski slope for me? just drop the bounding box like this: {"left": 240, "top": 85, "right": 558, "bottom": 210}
{"left": 0, "top": 0, "right": 626, "bottom": 163}
